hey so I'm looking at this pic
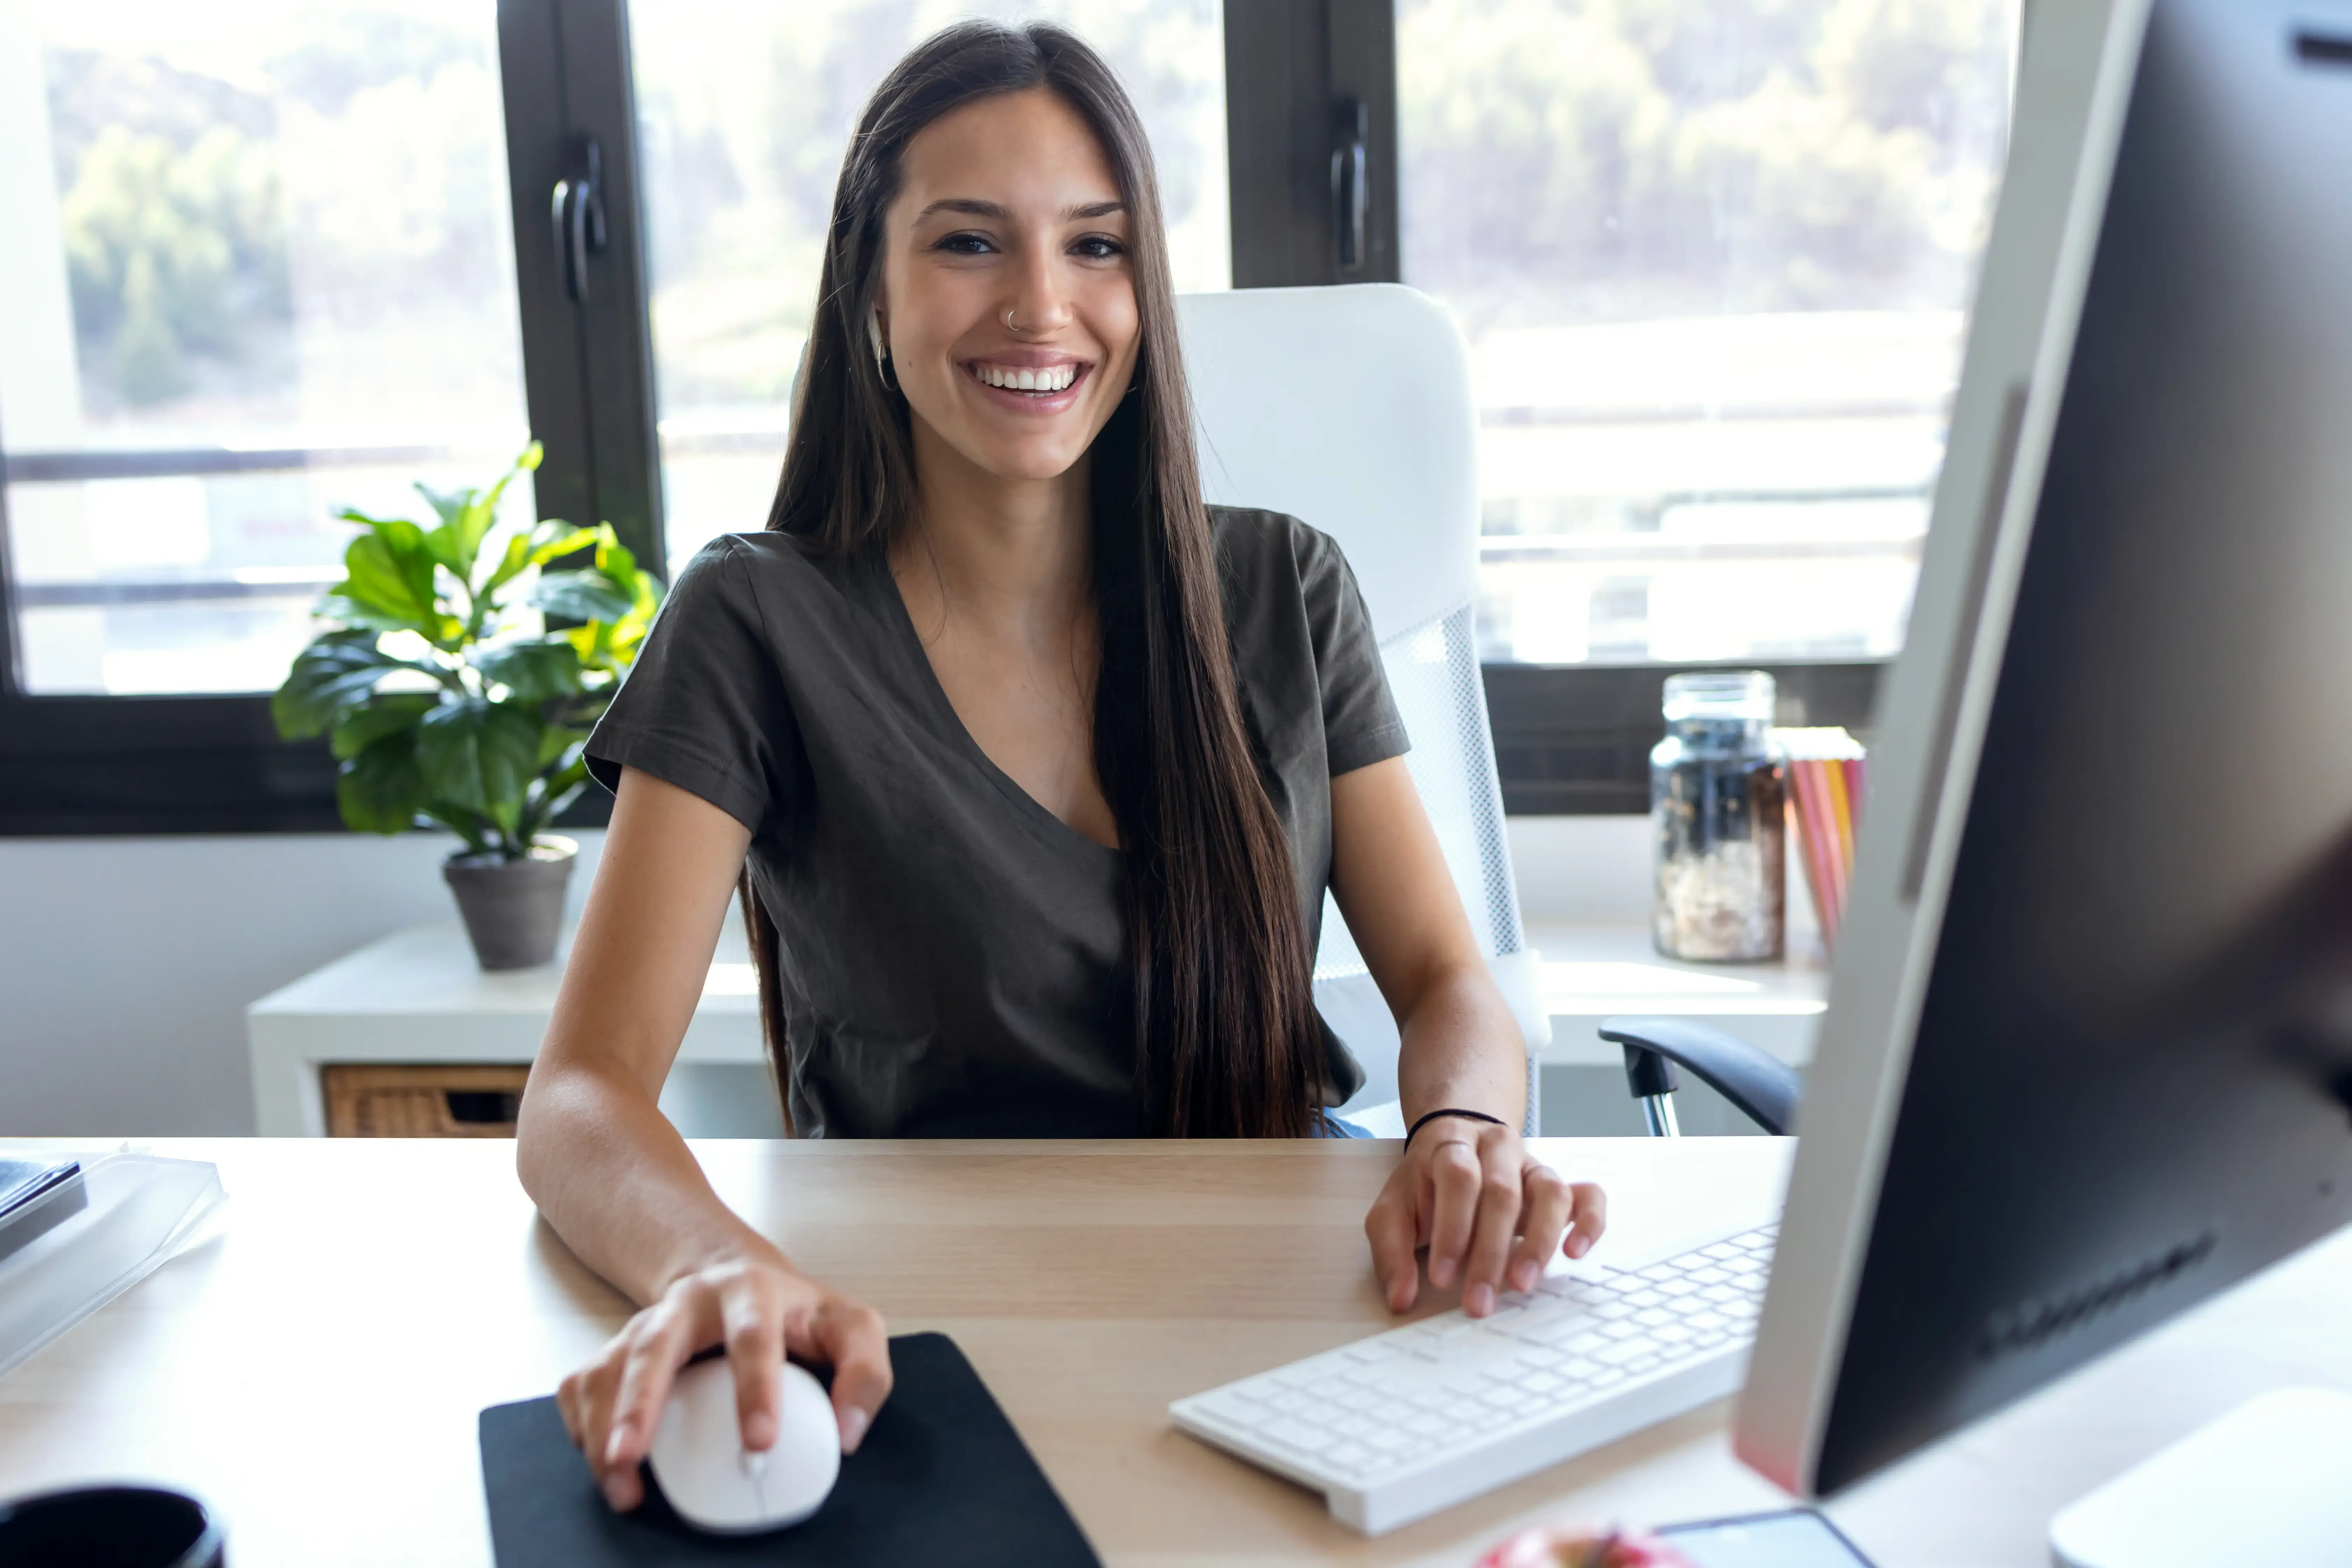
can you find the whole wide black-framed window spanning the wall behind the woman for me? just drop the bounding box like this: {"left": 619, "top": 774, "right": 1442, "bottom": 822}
{"left": 0, "top": 0, "right": 2018, "bottom": 832}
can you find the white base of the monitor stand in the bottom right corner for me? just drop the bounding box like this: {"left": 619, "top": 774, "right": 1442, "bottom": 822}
{"left": 2051, "top": 1390, "right": 2352, "bottom": 1568}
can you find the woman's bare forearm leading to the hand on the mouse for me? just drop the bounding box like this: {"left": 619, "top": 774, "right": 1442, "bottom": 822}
{"left": 515, "top": 1065, "right": 783, "bottom": 1305}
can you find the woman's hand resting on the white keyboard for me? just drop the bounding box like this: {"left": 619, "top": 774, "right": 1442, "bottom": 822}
{"left": 1364, "top": 1116, "right": 1609, "bottom": 1316}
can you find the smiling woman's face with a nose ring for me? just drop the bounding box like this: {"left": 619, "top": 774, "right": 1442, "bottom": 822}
{"left": 882, "top": 89, "right": 1138, "bottom": 479}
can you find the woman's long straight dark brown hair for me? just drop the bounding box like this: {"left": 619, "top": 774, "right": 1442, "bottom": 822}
{"left": 741, "top": 21, "right": 1322, "bottom": 1138}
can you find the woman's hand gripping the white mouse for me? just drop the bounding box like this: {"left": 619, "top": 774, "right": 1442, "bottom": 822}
{"left": 555, "top": 1255, "right": 891, "bottom": 1512}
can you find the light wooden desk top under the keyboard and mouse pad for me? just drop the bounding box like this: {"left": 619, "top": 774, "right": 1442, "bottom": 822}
{"left": 0, "top": 1138, "right": 2352, "bottom": 1568}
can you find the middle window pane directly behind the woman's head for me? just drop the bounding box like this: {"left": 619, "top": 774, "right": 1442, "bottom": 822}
{"left": 630, "top": 0, "right": 1232, "bottom": 569}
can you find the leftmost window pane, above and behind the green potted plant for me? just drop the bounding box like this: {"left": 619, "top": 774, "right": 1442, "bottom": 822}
{"left": 0, "top": 0, "right": 529, "bottom": 696}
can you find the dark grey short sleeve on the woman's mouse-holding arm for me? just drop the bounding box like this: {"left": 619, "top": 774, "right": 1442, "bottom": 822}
{"left": 588, "top": 534, "right": 800, "bottom": 834}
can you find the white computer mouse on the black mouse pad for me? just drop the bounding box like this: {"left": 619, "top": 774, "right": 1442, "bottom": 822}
{"left": 647, "top": 1357, "right": 842, "bottom": 1535}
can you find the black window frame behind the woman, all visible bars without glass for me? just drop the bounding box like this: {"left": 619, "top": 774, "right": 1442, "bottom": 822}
{"left": 0, "top": 0, "right": 1884, "bottom": 837}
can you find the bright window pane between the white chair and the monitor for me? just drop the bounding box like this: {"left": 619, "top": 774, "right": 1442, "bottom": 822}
{"left": 1395, "top": 0, "right": 2016, "bottom": 665}
